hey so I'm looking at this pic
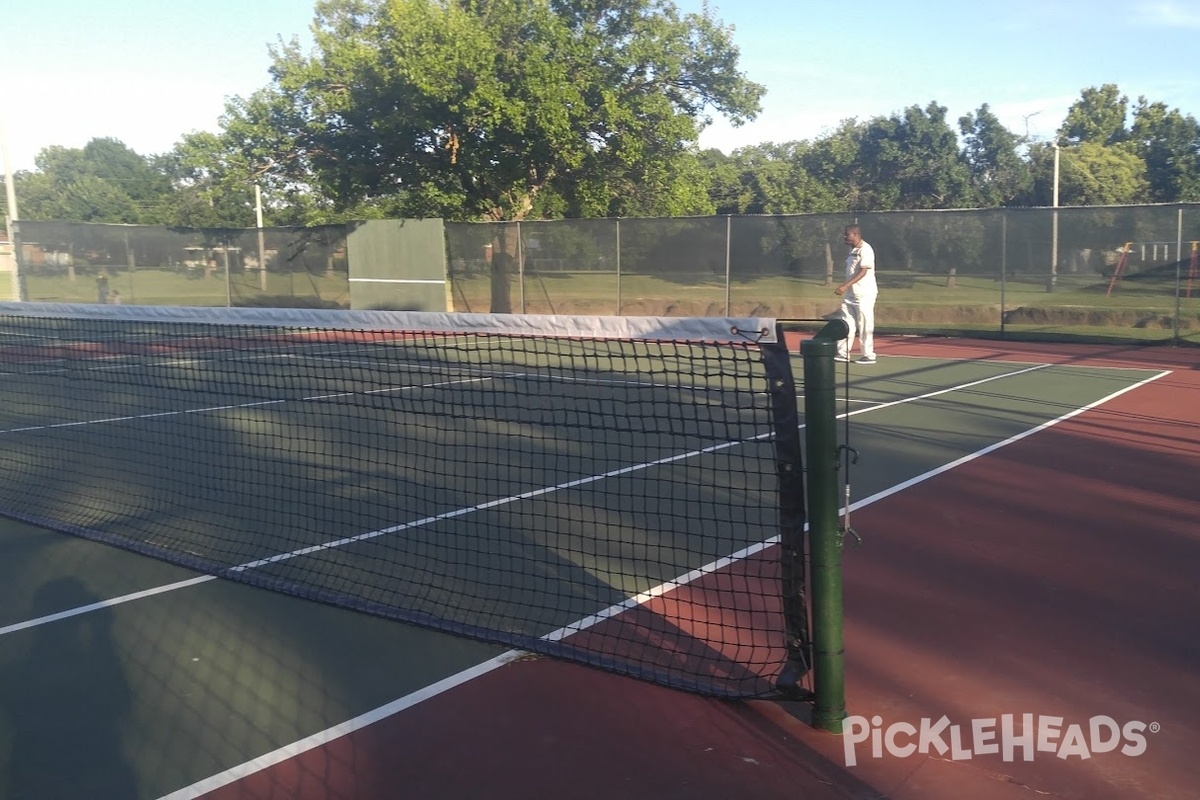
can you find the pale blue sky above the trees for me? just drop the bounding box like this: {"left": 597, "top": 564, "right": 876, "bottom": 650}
{"left": 0, "top": 0, "right": 1200, "bottom": 169}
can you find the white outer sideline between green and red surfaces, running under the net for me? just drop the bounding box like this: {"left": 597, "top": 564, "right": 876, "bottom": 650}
{"left": 152, "top": 369, "right": 1171, "bottom": 800}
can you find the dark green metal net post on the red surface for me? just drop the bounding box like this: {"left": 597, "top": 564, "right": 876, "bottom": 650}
{"left": 800, "top": 320, "right": 848, "bottom": 734}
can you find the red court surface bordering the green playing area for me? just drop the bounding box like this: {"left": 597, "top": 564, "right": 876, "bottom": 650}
{"left": 205, "top": 338, "right": 1200, "bottom": 800}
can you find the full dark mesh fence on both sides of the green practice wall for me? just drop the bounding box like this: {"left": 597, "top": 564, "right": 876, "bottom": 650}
{"left": 11, "top": 204, "right": 1200, "bottom": 343}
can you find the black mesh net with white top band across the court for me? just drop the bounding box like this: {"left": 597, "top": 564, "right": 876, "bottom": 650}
{"left": 0, "top": 303, "right": 806, "bottom": 697}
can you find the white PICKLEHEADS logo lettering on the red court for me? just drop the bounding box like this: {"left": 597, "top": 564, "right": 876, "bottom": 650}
{"left": 842, "top": 714, "right": 1160, "bottom": 766}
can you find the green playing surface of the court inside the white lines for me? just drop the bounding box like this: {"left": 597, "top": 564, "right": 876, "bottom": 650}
{"left": 0, "top": 340, "right": 1159, "bottom": 799}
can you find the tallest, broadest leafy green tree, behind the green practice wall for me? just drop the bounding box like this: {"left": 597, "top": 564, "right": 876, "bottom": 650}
{"left": 227, "top": 0, "right": 763, "bottom": 219}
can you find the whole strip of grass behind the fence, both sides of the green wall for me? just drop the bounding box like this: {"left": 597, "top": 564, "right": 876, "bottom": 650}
{"left": 11, "top": 269, "right": 1200, "bottom": 344}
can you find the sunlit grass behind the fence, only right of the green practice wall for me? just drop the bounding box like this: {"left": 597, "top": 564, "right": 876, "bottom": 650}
{"left": 452, "top": 272, "right": 1200, "bottom": 343}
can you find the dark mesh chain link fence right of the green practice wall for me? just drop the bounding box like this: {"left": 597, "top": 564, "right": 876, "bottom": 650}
{"left": 446, "top": 204, "right": 1200, "bottom": 343}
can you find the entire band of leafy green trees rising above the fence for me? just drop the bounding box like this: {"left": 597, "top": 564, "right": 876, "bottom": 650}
{"left": 9, "top": 72, "right": 1200, "bottom": 228}
